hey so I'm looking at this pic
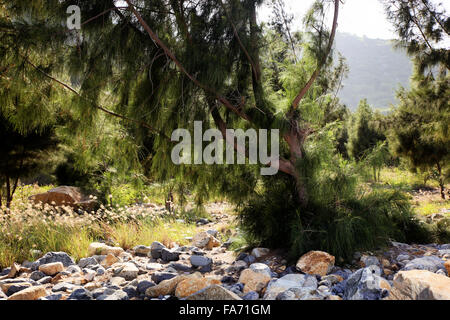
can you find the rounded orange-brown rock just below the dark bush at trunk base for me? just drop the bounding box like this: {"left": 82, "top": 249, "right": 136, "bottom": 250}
{"left": 296, "top": 251, "right": 335, "bottom": 276}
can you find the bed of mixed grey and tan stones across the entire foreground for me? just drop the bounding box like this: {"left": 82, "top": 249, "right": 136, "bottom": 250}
{"left": 0, "top": 213, "right": 450, "bottom": 300}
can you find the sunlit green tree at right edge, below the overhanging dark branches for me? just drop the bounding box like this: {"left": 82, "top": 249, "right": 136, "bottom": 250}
{"left": 389, "top": 73, "right": 450, "bottom": 198}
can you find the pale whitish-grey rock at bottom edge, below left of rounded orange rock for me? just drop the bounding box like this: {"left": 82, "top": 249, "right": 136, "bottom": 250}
{"left": 264, "top": 274, "right": 317, "bottom": 300}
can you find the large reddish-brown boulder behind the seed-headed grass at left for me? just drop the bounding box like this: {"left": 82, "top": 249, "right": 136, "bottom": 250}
{"left": 28, "top": 186, "right": 98, "bottom": 211}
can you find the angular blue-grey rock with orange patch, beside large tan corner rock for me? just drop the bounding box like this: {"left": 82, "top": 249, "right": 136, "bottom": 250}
{"left": 344, "top": 268, "right": 390, "bottom": 300}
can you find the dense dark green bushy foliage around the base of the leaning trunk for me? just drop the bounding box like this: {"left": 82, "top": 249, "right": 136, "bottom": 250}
{"left": 239, "top": 124, "right": 430, "bottom": 259}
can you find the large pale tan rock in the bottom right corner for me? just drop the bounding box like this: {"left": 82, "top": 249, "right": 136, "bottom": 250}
{"left": 388, "top": 270, "right": 450, "bottom": 300}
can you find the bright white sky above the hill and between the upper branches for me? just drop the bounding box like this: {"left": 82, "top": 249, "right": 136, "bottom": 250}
{"left": 258, "top": 0, "right": 450, "bottom": 40}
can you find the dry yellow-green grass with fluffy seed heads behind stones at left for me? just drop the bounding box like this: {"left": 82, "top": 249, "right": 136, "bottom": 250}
{"left": 0, "top": 195, "right": 195, "bottom": 268}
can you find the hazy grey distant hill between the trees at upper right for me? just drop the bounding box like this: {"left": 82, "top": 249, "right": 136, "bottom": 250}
{"left": 336, "top": 33, "right": 412, "bottom": 110}
